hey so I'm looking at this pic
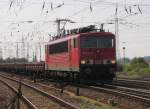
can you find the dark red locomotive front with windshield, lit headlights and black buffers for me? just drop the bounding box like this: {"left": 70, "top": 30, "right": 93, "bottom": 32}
{"left": 80, "top": 32, "right": 116, "bottom": 81}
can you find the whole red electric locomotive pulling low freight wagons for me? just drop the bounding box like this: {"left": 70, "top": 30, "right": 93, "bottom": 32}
{"left": 45, "top": 25, "right": 116, "bottom": 81}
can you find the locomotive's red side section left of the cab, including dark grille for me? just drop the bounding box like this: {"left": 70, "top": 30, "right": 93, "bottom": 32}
{"left": 46, "top": 39, "right": 72, "bottom": 71}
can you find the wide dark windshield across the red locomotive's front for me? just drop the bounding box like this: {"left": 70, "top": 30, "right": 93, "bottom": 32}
{"left": 81, "top": 37, "right": 113, "bottom": 48}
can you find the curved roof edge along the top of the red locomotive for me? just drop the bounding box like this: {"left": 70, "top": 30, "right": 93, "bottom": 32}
{"left": 46, "top": 32, "right": 115, "bottom": 45}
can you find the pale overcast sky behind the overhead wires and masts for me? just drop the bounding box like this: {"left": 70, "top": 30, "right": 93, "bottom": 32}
{"left": 0, "top": 0, "right": 150, "bottom": 60}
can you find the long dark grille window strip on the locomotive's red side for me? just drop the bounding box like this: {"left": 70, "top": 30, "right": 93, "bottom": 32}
{"left": 49, "top": 41, "right": 68, "bottom": 54}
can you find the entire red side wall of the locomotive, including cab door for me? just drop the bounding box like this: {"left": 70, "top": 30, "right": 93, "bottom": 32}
{"left": 45, "top": 36, "right": 79, "bottom": 72}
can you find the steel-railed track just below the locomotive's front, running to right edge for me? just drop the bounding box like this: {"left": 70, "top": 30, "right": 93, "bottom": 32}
{"left": 75, "top": 85, "right": 150, "bottom": 104}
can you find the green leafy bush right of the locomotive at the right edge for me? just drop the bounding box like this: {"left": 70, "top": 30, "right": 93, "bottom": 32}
{"left": 123, "top": 58, "right": 150, "bottom": 75}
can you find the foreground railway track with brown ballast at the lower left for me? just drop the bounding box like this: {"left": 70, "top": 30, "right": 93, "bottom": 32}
{"left": 0, "top": 74, "right": 79, "bottom": 109}
